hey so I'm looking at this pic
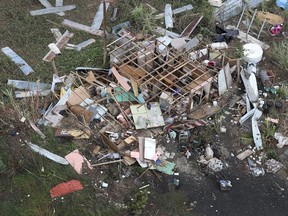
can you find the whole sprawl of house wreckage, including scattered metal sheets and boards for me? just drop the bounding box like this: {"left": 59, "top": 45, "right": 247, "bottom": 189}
{"left": 2, "top": 1, "right": 288, "bottom": 202}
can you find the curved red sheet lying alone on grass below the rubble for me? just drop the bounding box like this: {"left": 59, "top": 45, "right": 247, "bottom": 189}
{"left": 50, "top": 180, "right": 83, "bottom": 198}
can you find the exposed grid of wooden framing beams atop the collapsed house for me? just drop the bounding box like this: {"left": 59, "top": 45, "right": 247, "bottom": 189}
{"left": 108, "top": 33, "right": 216, "bottom": 112}
